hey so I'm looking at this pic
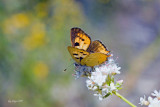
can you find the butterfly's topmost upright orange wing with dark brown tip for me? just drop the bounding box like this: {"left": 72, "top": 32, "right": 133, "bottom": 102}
{"left": 71, "top": 28, "right": 91, "bottom": 50}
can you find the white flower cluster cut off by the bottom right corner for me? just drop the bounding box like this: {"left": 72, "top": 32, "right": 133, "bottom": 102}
{"left": 139, "top": 90, "right": 160, "bottom": 107}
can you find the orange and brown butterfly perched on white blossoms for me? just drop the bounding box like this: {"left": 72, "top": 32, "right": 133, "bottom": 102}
{"left": 68, "top": 27, "right": 111, "bottom": 67}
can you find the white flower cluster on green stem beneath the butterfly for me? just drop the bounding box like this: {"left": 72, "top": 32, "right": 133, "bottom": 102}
{"left": 86, "top": 59, "right": 123, "bottom": 100}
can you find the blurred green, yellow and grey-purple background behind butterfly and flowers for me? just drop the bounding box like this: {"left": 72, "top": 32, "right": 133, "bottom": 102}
{"left": 0, "top": 0, "right": 160, "bottom": 107}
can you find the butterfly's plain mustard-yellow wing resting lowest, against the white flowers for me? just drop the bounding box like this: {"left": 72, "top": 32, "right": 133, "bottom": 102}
{"left": 81, "top": 53, "right": 110, "bottom": 66}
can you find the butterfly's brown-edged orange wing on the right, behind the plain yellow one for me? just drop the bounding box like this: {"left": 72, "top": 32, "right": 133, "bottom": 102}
{"left": 87, "top": 40, "right": 110, "bottom": 54}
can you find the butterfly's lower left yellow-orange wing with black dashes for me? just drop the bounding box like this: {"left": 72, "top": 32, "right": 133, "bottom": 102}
{"left": 68, "top": 46, "right": 89, "bottom": 64}
